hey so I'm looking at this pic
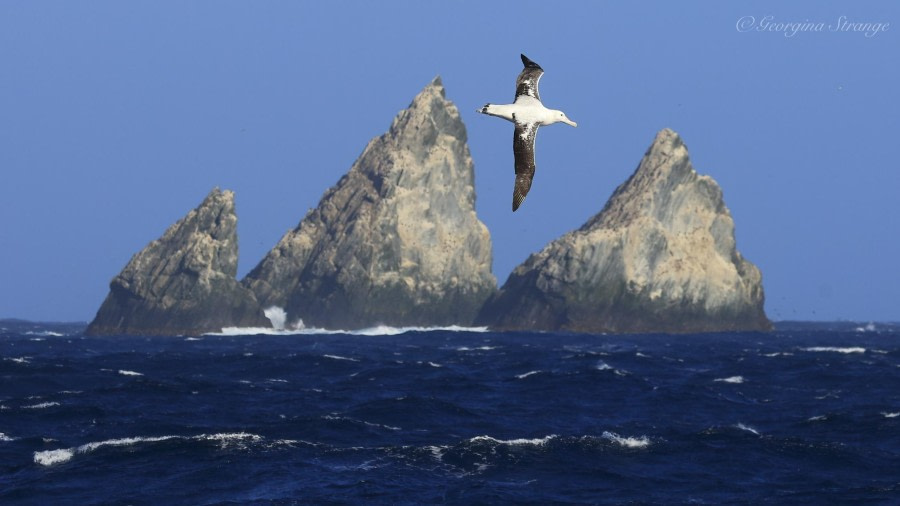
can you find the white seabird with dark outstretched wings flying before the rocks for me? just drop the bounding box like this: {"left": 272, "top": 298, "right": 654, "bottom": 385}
{"left": 476, "top": 54, "right": 578, "bottom": 212}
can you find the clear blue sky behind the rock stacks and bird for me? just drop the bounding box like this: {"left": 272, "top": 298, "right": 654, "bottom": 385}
{"left": 0, "top": 0, "right": 900, "bottom": 321}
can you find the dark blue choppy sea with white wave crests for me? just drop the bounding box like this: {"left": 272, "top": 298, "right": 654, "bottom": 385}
{"left": 0, "top": 321, "right": 900, "bottom": 505}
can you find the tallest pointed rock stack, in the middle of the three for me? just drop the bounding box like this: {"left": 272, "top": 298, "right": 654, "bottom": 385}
{"left": 243, "top": 78, "right": 496, "bottom": 328}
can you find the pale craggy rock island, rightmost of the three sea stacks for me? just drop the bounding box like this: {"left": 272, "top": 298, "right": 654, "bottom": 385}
{"left": 477, "top": 129, "right": 771, "bottom": 332}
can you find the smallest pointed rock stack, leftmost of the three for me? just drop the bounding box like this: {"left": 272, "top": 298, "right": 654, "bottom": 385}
{"left": 87, "top": 188, "right": 269, "bottom": 335}
